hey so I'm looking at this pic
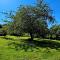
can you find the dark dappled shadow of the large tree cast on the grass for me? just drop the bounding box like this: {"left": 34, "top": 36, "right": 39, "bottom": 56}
{"left": 8, "top": 39, "right": 60, "bottom": 51}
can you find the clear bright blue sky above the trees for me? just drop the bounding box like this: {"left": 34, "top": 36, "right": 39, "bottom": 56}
{"left": 0, "top": 0, "right": 60, "bottom": 24}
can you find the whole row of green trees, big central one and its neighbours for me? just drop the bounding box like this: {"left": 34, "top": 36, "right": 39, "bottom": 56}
{"left": 0, "top": 0, "right": 60, "bottom": 40}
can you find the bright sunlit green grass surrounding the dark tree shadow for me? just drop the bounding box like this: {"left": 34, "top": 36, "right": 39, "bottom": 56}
{"left": 0, "top": 36, "right": 60, "bottom": 60}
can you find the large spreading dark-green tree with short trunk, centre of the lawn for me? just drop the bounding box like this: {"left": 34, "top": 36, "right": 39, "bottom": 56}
{"left": 10, "top": 0, "right": 54, "bottom": 40}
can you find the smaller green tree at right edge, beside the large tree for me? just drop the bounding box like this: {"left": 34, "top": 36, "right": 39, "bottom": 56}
{"left": 50, "top": 25, "right": 60, "bottom": 39}
